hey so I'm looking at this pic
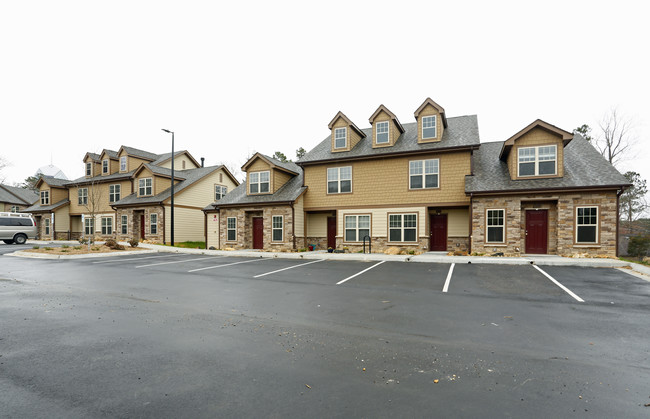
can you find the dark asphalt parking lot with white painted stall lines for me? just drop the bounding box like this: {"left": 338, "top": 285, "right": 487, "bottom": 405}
{"left": 0, "top": 254, "right": 650, "bottom": 417}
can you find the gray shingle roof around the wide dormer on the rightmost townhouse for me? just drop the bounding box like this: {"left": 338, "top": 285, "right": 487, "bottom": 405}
{"left": 465, "top": 134, "right": 630, "bottom": 193}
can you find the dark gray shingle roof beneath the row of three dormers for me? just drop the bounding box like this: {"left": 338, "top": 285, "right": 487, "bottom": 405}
{"left": 298, "top": 115, "right": 481, "bottom": 164}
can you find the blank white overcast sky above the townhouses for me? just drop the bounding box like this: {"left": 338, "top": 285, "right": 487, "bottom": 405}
{"left": 0, "top": 0, "right": 650, "bottom": 190}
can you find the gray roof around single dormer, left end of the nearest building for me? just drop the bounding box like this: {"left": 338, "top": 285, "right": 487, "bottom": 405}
{"left": 204, "top": 170, "right": 307, "bottom": 210}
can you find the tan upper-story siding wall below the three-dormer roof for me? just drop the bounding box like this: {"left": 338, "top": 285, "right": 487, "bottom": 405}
{"left": 305, "top": 152, "right": 470, "bottom": 211}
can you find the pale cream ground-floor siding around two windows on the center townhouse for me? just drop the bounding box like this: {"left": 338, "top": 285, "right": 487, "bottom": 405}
{"left": 334, "top": 207, "right": 429, "bottom": 237}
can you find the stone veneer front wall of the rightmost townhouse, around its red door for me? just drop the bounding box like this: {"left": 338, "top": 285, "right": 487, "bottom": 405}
{"left": 472, "top": 191, "right": 617, "bottom": 256}
